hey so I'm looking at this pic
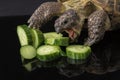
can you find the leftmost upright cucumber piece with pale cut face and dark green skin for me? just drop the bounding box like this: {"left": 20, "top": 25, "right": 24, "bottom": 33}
{"left": 17, "top": 25, "right": 33, "bottom": 46}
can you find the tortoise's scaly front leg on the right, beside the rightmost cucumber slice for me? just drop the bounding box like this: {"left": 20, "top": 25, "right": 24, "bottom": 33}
{"left": 84, "top": 10, "right": 110, "bottom": 46}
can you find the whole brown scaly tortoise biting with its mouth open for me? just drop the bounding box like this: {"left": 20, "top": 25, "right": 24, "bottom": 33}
{"left": 28, "top": 0, "right": 120, "bottom": 46}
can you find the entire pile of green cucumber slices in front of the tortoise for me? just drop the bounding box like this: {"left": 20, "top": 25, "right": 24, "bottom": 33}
{"left": 17, "top": 25, "right": 91, "bottom": 61}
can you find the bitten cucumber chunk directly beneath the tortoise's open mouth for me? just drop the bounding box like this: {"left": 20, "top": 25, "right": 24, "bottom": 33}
{"left": 44, "top": 32, "right": 69, "bottom": 46}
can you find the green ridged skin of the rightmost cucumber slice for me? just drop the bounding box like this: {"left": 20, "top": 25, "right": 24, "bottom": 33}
{"left": 66, "top": 45, "right": 91, "bottom": 60}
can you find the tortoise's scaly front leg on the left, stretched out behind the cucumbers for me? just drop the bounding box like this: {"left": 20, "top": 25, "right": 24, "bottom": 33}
{"left": 28, "top": 2, "right": 64, "bottom": 29}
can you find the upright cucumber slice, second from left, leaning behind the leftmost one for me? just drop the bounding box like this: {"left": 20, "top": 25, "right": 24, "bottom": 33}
{"left": 31, "top": 29, "right": 44, "bottom": 48}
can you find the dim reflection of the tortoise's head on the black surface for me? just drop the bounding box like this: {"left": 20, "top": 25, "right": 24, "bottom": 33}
{"left": 57, "top": 58, "right": 86, "bottom": 77}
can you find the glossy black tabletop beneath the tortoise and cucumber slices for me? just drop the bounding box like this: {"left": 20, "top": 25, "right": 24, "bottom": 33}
{"left": 0, "top": 16, "right": 120, "bottom": 80}
